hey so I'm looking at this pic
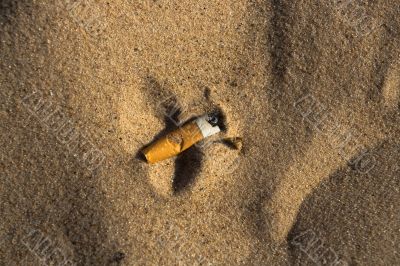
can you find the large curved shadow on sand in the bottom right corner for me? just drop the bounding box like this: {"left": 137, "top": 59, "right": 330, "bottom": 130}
{"left": 287, "top": 142, "right": 400, "bottom": 265}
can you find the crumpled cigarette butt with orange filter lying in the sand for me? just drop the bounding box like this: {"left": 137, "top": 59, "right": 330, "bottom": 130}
{"left": 143, "top": 115, "right": 221, "bottom": 164}
